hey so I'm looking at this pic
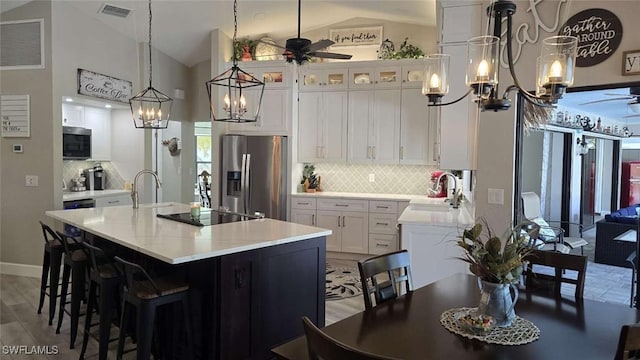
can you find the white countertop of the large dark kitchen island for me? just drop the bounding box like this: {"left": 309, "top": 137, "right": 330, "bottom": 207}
{"left": 46, "top": 203, "right": 331, "bottom": 264}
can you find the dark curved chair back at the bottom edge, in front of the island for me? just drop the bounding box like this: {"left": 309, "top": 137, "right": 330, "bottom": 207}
{"left": 302, "top": 316, "right": 395, "bottom": 360}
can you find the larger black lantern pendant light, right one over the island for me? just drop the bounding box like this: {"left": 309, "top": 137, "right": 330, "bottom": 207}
{"left": 206, "top": 0, "right": 264, "bottom": 122}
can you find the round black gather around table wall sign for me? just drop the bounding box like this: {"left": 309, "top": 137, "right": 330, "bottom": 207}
{"left": 559, "top": 9, "right": 622, "bottom": 67}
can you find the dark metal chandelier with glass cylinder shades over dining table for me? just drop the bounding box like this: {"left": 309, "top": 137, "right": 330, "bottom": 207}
{"left": 422, "top": 0, "right": 578, "bottom": 111}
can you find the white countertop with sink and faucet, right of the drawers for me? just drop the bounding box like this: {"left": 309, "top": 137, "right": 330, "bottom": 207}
{"left": 398, "top": 204, "right": 474, "bottom": 227}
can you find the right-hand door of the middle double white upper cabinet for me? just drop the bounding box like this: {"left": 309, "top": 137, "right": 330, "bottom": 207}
{"left": 369, "top": 89, "right": 401, "bottom": 164}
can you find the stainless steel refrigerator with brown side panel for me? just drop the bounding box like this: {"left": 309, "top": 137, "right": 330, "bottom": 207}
{"left": 220, "top": 135, "right": 288, "bottom": 220}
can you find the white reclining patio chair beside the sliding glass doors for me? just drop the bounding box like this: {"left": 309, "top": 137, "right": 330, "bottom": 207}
{"left": 521, "top": 192, "right": 589, "bottom": 255}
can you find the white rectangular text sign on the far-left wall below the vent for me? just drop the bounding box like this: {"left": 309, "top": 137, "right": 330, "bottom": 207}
{"left": 0, "top": 95, "right": 31, "bottom": 137}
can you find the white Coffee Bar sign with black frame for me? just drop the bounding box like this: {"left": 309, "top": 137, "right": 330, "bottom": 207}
{"left": 78, "top": 69, "right": 132, "bottom": 103}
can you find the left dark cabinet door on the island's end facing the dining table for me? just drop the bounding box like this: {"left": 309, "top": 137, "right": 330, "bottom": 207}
{"left": 219, "top": 251, "right": 260, "bottom": 359}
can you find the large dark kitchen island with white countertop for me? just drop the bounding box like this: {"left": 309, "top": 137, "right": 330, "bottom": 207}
{"left": 46, "top": 203, "right": 331, "bottom": 359}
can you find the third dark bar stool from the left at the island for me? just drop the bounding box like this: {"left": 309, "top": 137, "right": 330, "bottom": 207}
{"left": 80, "top": 242, "right": 124, "bottom": 360}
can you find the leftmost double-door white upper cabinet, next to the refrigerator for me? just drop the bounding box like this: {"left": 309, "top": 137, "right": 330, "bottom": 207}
{"left": 298, "top": 91, "right": 347, "bottom": 163}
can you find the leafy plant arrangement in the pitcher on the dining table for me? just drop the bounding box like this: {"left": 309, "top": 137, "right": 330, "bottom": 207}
{"left": 458, "top": 221, "right": 531, "bottom": 284}
